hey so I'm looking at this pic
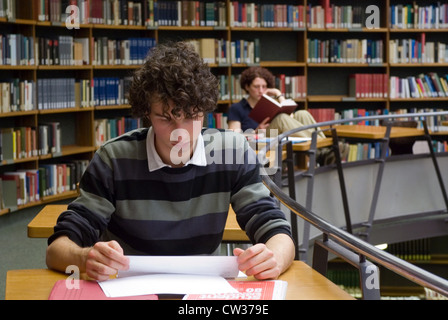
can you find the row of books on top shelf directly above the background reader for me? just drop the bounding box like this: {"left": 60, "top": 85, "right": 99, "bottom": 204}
{"left": 229, "top": 1, "right": 305, "bottom": 28}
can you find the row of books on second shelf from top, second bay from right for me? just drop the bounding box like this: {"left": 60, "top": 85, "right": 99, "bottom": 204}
{"left": 307, "top": 39, "right": 384, "bottom": 64}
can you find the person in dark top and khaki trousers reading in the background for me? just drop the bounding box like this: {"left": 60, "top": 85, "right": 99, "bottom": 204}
{"left": 228, "top": 67, "right": 325, "bottom": 138}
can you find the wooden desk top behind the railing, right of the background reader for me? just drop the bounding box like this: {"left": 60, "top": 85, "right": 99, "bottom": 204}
{"left": 334, "top": 125, "right": 425, "bottom": 140}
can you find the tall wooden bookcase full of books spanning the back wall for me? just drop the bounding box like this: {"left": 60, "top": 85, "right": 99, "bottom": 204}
{"left": 0, "top": 0, "right": 448, "bottom": 212}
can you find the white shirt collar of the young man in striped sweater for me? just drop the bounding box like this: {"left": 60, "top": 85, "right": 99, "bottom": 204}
{"left": 146, "top": 127, "right": 207, "bottom": 172}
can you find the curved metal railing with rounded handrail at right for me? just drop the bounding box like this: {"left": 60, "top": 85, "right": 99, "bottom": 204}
{"left": 259, "top": 112, "right": 448, "bottom": 299}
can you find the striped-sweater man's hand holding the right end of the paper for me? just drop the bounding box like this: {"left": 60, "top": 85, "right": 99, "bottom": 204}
{"left": 233, "top": 243, "right": 282, "bottom": 280}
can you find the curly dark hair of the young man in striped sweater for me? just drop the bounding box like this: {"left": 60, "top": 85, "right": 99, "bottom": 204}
{"left": 129, "top": 42, "right": 219, "bottom": 120}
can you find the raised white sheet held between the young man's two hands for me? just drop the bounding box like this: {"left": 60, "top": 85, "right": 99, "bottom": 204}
{"left": 118, "top": 256, "right": 239, "bottom": 278}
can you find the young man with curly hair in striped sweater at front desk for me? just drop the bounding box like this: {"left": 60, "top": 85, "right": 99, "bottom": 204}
{"left": 47, "top": 42, "right": 294, "bottom": 280}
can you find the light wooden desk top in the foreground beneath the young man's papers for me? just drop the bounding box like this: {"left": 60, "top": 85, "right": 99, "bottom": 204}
{"left": 5, "top": 261, "right": 354, "bottom": 300}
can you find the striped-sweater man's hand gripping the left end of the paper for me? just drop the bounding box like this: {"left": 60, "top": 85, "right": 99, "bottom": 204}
{"left": 86, "top": 241, "right": 129, "bottom": 281}
